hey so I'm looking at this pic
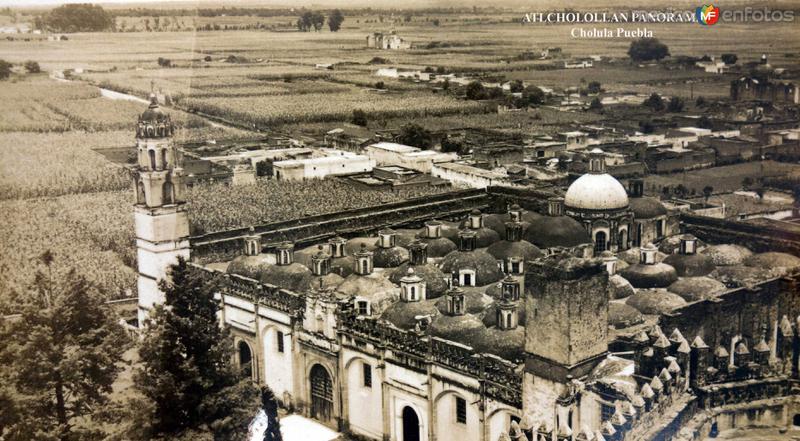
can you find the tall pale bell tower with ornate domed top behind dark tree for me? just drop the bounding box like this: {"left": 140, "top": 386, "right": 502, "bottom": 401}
{"left": 133, "top": 96, "right": 189, "bottom": 326}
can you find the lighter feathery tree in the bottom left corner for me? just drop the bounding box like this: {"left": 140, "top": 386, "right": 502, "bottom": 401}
{"left": 0, "top": 260, "right": 128, "bottom": 441}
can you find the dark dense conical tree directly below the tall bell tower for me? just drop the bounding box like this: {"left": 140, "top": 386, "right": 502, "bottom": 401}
{"left": 134, "top": 259, "right": 258, "bottom": 440}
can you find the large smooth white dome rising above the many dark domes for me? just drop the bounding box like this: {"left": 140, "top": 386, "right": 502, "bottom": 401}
{"left": 564, "top": 173, "right": 628, "bottom": 210}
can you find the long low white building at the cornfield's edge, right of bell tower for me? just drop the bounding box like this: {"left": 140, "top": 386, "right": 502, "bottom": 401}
{"left": 273, "top": 154, "right": 375, "bottom": 181}
